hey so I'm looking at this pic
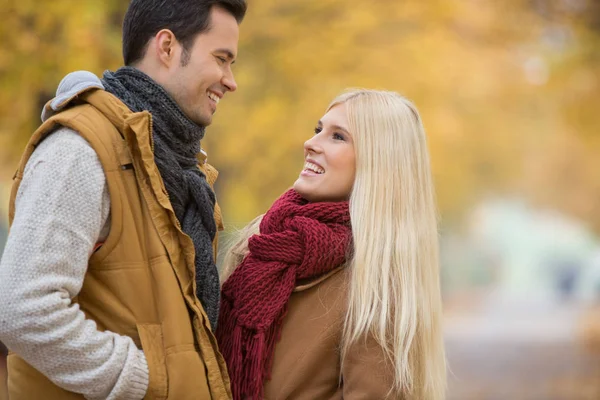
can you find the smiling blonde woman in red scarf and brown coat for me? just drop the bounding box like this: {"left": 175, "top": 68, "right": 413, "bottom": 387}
{"left": 217, "top": 90, "right": 446, "bottom": 400}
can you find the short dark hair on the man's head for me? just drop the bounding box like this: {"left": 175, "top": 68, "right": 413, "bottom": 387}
{"left": 123, "top": 0, "right": 247, "bottom": 65}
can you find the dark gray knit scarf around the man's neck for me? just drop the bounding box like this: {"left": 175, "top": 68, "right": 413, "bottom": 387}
{"left": 102, "top": 67, "right": 220, "bottom": 331}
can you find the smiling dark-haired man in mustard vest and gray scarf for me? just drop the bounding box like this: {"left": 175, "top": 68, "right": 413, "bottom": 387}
{"left": 0, "top": 0, "right": 246, "bottom": 400}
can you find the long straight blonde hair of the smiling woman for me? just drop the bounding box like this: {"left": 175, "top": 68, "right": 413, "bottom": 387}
{"left": 224, "top": 89, "right": 446, "bottom": 400}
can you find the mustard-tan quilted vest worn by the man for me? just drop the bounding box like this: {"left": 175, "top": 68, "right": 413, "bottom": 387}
{"left": 8, "top": 89, "right": 231, "bottom": 400}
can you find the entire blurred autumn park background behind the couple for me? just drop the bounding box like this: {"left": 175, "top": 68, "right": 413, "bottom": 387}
{"left": 0, "top": 0, "right": 600, "bottom": 400}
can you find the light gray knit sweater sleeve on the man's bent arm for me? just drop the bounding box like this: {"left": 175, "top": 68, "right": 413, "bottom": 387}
{"left": 0, "top": 128, "right": 148, "bottom": 400}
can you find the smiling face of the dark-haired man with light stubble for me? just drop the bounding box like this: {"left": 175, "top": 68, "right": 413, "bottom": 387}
{"left": 161, "top": 7, "right": 239, "bottom": 126}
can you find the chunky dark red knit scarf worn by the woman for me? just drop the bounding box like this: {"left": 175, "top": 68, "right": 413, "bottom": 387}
{"left": 217, "top": 190, "right": 352, "bottom": 400}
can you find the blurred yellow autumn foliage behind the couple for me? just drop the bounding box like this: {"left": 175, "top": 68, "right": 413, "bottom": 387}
{"left": 0, "top": 0, "right": 600, "bottom": 230}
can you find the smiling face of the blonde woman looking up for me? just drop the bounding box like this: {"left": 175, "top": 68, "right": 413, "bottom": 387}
{"left": 294, "top": 103, "right": 356, "bottom": 202}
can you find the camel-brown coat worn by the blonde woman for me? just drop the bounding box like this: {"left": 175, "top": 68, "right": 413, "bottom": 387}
{"left": 264, "top": 269, "right": 392, "bottom": 400}
